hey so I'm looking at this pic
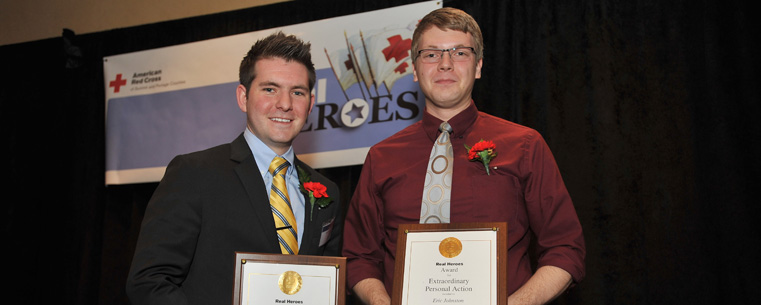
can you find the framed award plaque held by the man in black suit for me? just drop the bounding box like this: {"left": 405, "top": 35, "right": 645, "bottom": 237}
{"left": 233, "top": 252, "right": 346, "bottom": 305}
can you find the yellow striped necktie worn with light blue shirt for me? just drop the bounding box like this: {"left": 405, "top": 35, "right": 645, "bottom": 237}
{"left": 269, "top": 157, "right": 299, "bottom": 254}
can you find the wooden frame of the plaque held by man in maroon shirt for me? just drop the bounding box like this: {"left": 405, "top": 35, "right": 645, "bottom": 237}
{"left": 391, "top": 222, "right": 508, "bottom": 305}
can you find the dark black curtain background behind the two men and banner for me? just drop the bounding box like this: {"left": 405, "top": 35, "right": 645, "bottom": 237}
{"left": 0, "top": 0, "right": 761, "bottom": 304}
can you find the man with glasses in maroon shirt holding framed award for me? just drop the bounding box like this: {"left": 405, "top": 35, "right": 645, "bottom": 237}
{"left": 343, "top": 8, "right": 585, "bottom": 304}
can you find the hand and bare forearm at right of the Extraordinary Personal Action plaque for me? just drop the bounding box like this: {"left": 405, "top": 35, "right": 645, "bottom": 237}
{"left": 504, "top": 266, "right": 571, "bottom": 305}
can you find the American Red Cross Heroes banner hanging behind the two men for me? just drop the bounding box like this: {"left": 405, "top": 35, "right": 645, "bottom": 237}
{"left": 103, "top": 1, "right": 441, "bottom": 184}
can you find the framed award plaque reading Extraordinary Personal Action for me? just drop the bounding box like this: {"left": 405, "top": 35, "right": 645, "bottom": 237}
{"left": 391, "top": 222, "right": 507, "bottom": 305}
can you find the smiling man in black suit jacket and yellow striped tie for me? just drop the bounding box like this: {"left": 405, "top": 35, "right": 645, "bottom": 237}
{"left": 126, "top": 33, "right": 343, "bottom": 305}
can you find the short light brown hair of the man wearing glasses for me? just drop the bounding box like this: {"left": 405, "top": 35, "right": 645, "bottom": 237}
{"left": 412, "top": 7, "right": 484, "bottom": 62}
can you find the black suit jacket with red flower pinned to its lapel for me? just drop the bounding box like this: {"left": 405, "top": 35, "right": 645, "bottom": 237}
{"left": 126, "top": 134, "right": 343, "bottom": 305}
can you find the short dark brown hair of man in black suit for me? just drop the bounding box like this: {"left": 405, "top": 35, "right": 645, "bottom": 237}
{"left": 238, "top": 31, "right": 316, "bottom": 95}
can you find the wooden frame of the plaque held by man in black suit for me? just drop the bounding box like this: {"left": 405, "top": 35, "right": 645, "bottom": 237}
{"left": 233, "top": 252, "right": 346, "bottom": 305}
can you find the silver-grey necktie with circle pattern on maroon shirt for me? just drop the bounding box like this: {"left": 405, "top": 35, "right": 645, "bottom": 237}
{"left": 420, "top": 122, "right": 454, "bottom": 223}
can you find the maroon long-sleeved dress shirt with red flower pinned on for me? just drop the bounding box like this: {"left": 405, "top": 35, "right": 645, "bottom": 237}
{"left": 343, "top": 102, "right": 585, "bottom": 294}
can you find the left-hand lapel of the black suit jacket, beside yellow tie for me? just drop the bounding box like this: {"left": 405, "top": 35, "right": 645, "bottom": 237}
{"left": 230, "top": 134, "right": 280, "bottom": 253}
